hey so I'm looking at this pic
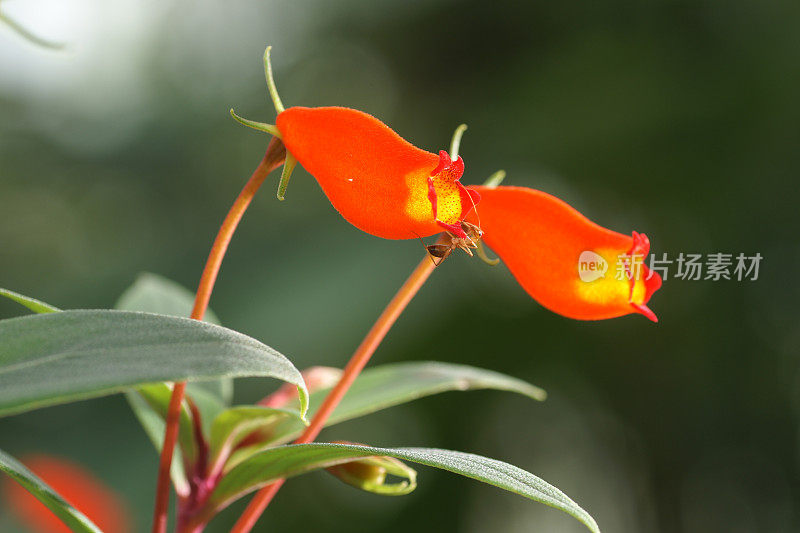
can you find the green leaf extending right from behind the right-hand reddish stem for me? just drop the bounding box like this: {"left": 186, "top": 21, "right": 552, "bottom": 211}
{"left": 239, "top": 361, "right": 547, "bottom": 454}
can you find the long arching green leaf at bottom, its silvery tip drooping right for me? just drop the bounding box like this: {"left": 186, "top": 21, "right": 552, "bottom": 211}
{"left": 208, "top": 444, "right": 600, "bottom": 533}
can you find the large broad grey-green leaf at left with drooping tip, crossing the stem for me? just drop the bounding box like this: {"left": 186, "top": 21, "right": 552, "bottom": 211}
{"left": 0, "top": 310, "right": 308, "bottom": 415}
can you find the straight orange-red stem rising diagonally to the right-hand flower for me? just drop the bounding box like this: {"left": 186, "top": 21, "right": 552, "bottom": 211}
{"left": 231, "top": 251, "right": 436, "bottom": 533}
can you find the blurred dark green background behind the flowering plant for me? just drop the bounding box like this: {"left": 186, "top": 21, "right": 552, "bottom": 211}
{"left": 0, "top": 0, "right": 800, "bottom": 533}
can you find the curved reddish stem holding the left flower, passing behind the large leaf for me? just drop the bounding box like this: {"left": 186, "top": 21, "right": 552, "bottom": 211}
{"left": 152, "top": 137, "right": 286, "bottom": 533}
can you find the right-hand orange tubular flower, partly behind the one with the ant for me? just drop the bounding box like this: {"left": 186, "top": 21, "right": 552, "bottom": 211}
{"left": 470, "top": 187, "right": 661, "bottom": 322}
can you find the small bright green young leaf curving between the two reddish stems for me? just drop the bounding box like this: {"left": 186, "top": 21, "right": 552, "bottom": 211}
{"left": 209, "top": 405, "right": 302, "bottom": 472}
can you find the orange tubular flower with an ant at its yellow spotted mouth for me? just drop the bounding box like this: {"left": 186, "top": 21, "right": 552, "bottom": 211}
{"left": 276, "top": 107, "right": 480, "bottom": 239}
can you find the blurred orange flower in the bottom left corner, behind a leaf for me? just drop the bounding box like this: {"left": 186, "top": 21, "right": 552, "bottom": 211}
{"left": 3, "top": 455, "right": 131, "bottom": 533}
